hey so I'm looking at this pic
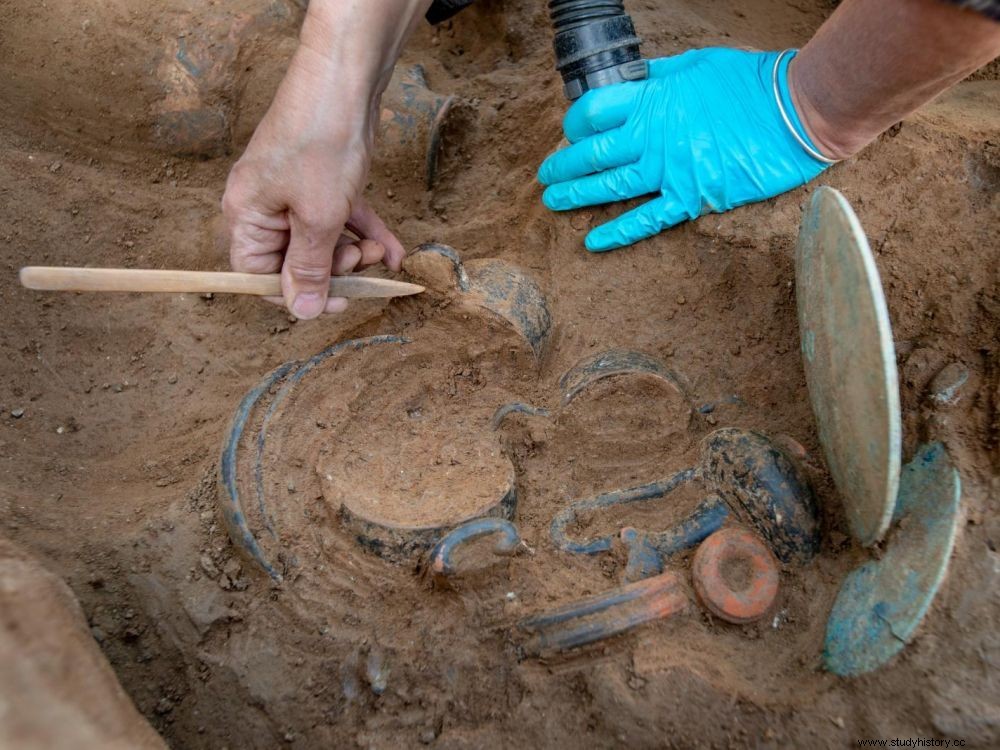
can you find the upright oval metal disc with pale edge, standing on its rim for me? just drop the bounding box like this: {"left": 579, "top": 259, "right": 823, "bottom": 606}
{"left": 795, "top": 187, "right": 902, "bottom": 546}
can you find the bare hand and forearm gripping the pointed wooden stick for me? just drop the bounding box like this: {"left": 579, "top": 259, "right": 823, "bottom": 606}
{"left": 222, "top": 0, "right": 430, "bottom": 319}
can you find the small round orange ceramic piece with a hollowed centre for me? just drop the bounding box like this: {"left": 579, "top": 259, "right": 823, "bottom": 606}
{"left": 691, "top": 528, "right": 778, "bottom": 623}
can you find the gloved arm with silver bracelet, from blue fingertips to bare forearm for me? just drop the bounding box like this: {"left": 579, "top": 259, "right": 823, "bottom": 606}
{"left": 539, "top": 0, "right": 1000, "bottom": 251}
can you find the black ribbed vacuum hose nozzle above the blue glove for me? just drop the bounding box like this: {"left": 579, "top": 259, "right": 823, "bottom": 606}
{"left": 549, "top": 0, "right": 648, "bottom": 101}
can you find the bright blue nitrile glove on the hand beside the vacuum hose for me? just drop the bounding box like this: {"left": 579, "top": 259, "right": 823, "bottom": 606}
{"left": 538, "top": 49, "right": 832, "bottom": 252}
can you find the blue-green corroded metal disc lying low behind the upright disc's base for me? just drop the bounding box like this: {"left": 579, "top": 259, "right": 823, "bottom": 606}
{"left": 823, "top": 443, "right": 961, "bottom": 676}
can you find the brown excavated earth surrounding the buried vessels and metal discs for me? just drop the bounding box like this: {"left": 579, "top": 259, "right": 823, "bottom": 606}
{"left": 0, "top": 0, "right": 1000, "bottom": 747}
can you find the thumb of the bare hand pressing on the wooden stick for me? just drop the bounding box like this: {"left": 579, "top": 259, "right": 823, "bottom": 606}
{"left": 281, "top": 212, "right": 343, "bottom": 320}
